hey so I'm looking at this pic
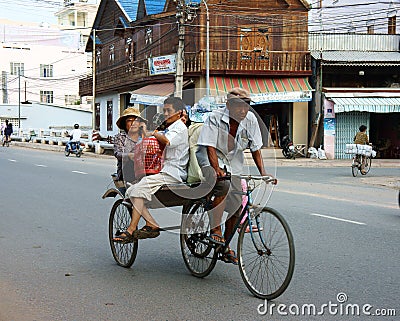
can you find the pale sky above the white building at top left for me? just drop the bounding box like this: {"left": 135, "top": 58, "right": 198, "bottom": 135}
{"left": 0, "top": 0, "right": 96, "bottom": 25}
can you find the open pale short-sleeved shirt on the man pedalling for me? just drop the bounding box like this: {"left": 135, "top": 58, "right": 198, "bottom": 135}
{"left": 197, "top": 107, "right": 263, "bottom": 175}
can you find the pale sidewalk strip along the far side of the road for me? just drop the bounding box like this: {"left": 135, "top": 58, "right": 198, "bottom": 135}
{"left": 10, "top": 141, "right": 400, "bottom": 169}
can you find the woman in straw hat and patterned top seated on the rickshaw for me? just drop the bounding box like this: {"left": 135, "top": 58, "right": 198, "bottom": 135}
{"left": 114, "top": 107, "right": 147, "bottom": 182}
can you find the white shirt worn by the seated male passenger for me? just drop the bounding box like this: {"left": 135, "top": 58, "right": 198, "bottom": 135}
{"left": 161, "top": 119, "right": 189, "bottom": 182}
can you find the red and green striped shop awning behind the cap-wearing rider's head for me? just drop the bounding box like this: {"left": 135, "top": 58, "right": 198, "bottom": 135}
{"left": 210, "top": 76, "right": 312, "bottom": 104}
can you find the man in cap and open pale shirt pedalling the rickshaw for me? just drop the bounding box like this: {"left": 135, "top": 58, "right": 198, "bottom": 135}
{"left": 196, "top": 88, "right": 266, "bottom": 264}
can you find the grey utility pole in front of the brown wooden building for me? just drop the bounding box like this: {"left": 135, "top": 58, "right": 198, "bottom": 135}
{"left": 174, "top": 0, "right": 186, "bottom": 98}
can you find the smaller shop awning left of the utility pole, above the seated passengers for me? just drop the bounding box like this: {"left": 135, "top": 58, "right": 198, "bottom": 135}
{"left": 130, "top": 81, "right": 189, "bottom": 105}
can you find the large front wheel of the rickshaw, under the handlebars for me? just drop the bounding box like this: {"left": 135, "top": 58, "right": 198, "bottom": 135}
{"left": 237, "top": 207, "right": 295, "bottom": 300}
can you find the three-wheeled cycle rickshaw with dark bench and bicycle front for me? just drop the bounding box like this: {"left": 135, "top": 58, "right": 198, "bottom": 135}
{"left": 103, "top": 175, "right": 295, "bottom": 300}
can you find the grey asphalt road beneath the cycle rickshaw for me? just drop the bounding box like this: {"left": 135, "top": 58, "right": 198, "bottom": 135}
{"left": 0, "top": 147, "right": 400, "bottom": 321}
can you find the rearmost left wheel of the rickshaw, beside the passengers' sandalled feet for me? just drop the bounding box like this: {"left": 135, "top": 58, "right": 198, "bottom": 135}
{"left": 108, "top": 199, "right": 138, "bottom": 268}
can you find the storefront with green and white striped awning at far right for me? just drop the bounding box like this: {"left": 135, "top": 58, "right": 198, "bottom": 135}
{"left": 324, "top": 91, "right": 400, "bottom": 159}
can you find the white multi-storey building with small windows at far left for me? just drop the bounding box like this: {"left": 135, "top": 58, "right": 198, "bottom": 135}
{"left": 0, "top": 24, "right": 87, "bottom": 106}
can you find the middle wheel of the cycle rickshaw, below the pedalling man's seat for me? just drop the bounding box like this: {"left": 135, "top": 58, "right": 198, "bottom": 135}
{"left": 180, "top": 201, "right": 217, "bottom": 278}
